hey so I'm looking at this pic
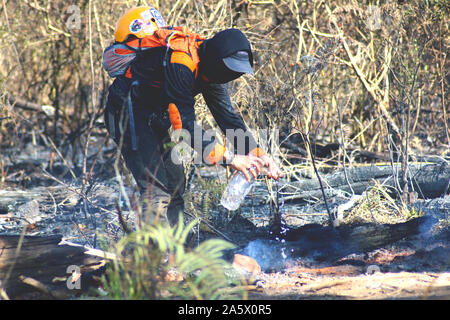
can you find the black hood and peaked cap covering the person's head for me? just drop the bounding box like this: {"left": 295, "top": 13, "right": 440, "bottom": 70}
{"left": 199, "top": 29, "right": 253, "bottom": 83}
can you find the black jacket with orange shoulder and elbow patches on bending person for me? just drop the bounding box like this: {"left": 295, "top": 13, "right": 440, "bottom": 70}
{"left": 108, "top": 38, "right": 262, "bottom": 165}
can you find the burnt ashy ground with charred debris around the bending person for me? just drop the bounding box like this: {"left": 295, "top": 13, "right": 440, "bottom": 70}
{"left": 0, "top": 141, "right": 450, "bottom": 299}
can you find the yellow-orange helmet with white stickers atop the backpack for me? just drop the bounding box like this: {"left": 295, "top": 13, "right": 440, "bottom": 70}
{"left": 114, "top": 6, "right": 166, "bottom": 42}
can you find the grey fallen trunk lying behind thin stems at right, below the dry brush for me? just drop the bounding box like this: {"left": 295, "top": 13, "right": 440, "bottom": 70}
{"left": 280, "top": 162, "right": 450, "bottom": 200}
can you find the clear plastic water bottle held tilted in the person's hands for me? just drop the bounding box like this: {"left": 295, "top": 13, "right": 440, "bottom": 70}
{"left": 220, "top": 171, "right": 255, "bottom": 210}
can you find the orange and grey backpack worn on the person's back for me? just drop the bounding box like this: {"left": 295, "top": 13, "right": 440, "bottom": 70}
{"left": 103, "top": 27, "right": 204, "bottom": 78}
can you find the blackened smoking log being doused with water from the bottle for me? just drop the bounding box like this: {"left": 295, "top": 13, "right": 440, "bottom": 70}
{"left": 246, "top": 217, "right": 433, "bottom": 272}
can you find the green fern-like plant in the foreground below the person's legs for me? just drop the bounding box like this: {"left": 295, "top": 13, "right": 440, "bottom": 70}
{"left": 104, "top": 217, "right": 244, "bottom": 300}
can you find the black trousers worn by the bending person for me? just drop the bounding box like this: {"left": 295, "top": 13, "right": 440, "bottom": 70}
{"left": 105, "top": 101, "right": 186, "bottom": 225}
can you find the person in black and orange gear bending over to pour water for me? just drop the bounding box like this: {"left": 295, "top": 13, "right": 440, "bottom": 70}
{"left": 103, "top": 7, "right": 282, "bottom": 224}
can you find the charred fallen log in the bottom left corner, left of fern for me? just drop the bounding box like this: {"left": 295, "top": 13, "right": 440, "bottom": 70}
{"left": 0, "top": 235, "right": 106, "bottom": 299}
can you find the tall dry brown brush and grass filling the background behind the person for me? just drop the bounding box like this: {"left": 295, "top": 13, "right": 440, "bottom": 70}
{"left": 0, "top": 0, "right": 450, "bottom": 192}
